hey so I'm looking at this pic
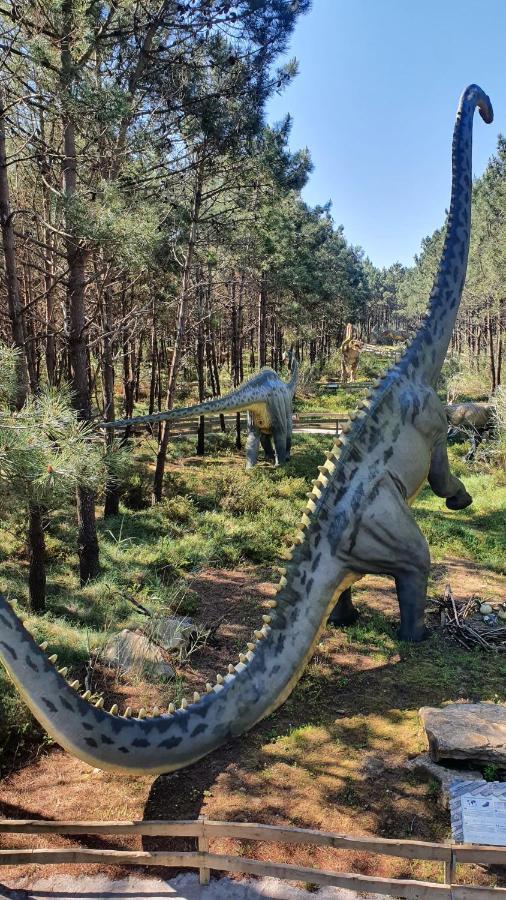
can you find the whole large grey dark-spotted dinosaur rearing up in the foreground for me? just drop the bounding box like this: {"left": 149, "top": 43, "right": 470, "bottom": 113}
{"left": 0, "top": 85, "right": 492, "bottom": 774}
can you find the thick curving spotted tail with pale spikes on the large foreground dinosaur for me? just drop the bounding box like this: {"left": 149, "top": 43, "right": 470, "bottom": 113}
{"left": 0, "top": 443, "right": 350, "bottom": 774}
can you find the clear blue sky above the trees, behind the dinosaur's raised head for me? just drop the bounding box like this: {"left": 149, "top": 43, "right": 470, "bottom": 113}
{"left": 267, "top": 0, "right": 506, "bottom": 266}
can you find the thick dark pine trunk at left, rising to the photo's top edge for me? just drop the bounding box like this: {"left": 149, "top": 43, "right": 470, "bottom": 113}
{"left": 60, "top": 0, "right": 100, "bottom": 584}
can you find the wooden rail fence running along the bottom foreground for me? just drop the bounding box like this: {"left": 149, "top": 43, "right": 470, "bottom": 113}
{"left": 0, "top": 816, "right": 506, "bottom": 900}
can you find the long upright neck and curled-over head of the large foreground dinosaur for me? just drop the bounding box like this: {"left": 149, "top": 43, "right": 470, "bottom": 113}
{"left": 399, "top": 84, "right": 493, "bottom": 386}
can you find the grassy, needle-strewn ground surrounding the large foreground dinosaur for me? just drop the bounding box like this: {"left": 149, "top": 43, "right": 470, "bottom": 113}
{"left": 0, "top": 378, "right": 506, "bottom": 877}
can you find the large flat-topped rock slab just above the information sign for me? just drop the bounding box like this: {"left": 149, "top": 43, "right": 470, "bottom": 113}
{"left": 420, "top": 703, "right": 506, "bottom": 767}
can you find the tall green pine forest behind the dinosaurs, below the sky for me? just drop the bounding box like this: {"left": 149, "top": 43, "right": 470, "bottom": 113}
{"left": 0, "top": 0, "right": 506, "bottom": 624}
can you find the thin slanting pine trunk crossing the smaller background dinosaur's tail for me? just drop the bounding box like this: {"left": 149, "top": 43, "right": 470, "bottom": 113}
{"left": 152, "top": 152, "right": 205, "bottom": 503}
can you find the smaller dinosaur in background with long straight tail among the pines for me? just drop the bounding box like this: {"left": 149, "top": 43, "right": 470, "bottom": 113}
{"left": 101, "top": 355, "right": 298, "bottom": 469}
